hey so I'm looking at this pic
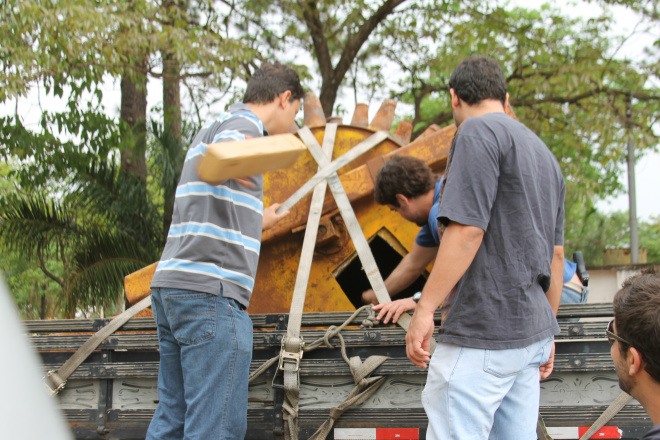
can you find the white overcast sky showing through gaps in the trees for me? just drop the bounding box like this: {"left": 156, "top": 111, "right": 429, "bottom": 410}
{"left": 0, "top": 0, "right": 660, "bottom": 221}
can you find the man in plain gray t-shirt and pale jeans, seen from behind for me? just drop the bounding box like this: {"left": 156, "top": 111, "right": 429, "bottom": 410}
{"left": 406, "top": 56, "right": 565, "bottom": 440}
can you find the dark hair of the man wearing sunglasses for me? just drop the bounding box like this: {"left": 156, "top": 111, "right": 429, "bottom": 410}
{"left": 614, "top": 269, "right": 660, "bottom": 382}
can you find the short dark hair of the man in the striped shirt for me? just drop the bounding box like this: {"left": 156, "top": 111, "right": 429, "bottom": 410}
{"left": 243, "top": 63, "right": 305, "bottom": 104}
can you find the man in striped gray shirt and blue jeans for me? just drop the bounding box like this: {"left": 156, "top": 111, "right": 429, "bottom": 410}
{"left": 147, "top": 63, "right": 304, "bottom": 440}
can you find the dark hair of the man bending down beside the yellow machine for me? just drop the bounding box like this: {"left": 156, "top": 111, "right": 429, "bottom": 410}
{"left": 374, "top": 156, "right": 437, "bottom": 207}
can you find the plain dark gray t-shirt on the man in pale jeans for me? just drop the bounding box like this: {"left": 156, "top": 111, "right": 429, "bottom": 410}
{"left": 438, "top": 113, "right": 566, "bottom": 349}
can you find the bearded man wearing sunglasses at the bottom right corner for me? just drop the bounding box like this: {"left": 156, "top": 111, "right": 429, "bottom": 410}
{"left": 607, "top": 272, "right": 660, "bottom": 440}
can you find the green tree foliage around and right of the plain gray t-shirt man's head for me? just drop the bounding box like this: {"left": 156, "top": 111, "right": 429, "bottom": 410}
{"left": 383, "top": 2, "right": 660, "bottom": 241}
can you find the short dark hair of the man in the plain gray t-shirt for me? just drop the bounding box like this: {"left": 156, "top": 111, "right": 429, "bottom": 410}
{"left": 449, "top": 55, "right": 506, "bottom": 105}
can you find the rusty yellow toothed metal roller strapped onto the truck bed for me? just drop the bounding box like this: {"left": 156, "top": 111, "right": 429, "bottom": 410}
{"left": 125, "top": 94, "right": 455, "bottom": 314}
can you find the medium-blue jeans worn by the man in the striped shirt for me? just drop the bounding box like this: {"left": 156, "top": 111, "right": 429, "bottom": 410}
{"left": 146, "top": 289, "right": 252, "bottom": 440}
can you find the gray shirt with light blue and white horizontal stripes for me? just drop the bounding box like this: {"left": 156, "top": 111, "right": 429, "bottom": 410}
{"left": 151, "top": 104, "right": 267, "bottom": 308}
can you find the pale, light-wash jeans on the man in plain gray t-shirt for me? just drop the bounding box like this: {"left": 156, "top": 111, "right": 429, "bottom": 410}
{"left": 422, "top": 338, "right": 552, "bottom": 440}
